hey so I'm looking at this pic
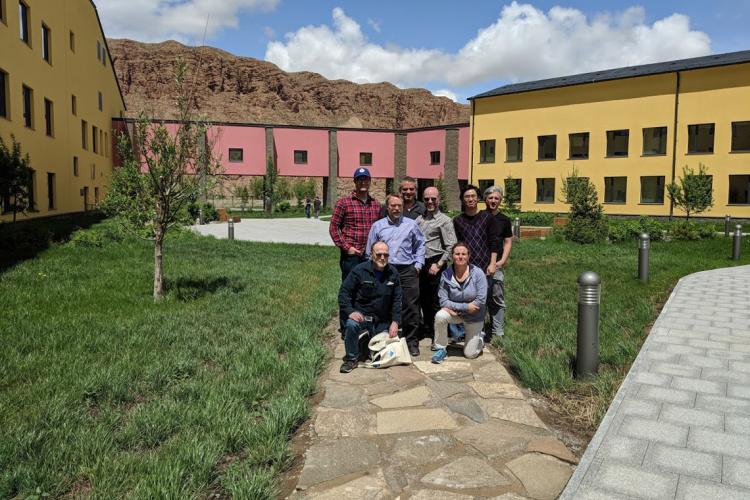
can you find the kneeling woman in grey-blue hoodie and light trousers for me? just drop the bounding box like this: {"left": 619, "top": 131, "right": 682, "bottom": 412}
{"left": 432, "top": 242, "right": 487, "bottom": 364}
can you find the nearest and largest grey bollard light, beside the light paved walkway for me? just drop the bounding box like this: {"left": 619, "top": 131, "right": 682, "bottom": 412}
{"left": 576, "top": 271, "right": 602, "bottom": 378}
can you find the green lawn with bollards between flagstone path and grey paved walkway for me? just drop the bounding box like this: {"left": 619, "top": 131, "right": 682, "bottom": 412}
{"left": 498, "top": 238, "right": 750, "bottom": 426}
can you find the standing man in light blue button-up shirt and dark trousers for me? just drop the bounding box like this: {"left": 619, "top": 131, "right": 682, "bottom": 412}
{"left": 366, "top": 194, "right": 424, "bottom": 356}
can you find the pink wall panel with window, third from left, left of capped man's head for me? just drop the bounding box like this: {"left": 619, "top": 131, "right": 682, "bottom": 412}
{"left": 273, "top": 128, "right": 328, "bottom": 177}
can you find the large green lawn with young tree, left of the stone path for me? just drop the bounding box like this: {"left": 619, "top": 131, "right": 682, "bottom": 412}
{"left": 0, "top": 223, "right": 339, "bottom": 498}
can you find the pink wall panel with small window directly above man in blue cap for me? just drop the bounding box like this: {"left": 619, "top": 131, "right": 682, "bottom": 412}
{"left": 336, "top": 130, "right": 396, "bottom": 178}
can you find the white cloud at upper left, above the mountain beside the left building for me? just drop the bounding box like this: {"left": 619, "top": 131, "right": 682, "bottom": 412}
{"left": 96, "top": 0, "right": 279, "bottom": 43}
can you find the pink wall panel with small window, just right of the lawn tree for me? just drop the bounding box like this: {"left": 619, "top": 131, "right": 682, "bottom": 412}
{"left": 208, "top": 125, "right": 266, "bottom": 175}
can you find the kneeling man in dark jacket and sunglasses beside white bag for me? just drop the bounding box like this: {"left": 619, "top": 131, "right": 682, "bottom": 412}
{"left": 339, "top": 241, "right": 401, "bottom": 373}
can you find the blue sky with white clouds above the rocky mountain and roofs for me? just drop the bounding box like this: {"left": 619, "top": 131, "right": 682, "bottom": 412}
{"left": 96, "top": 0, "right": 750, "bottom": 101}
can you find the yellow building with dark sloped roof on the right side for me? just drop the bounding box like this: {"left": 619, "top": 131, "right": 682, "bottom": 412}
{"left": 470, "top": 51, "right": 750, "bottom": 217}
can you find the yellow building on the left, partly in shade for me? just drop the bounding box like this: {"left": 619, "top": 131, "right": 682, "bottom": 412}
{"left": 0, "top": 0, "right": 125, "bottom": 222}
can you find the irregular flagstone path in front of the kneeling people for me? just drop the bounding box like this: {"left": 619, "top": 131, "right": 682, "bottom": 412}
{"left": 290, "top": 341, "right": 576, "bottom": 500}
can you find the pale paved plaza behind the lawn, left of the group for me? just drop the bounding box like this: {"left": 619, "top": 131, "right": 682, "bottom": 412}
{"left": 191, "top": 218, "right": 333, "bottom": 246}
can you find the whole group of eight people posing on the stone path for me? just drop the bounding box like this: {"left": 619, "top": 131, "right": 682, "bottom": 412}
{"left": 329, "top": 167, "right": 513, "bottom": 373}
